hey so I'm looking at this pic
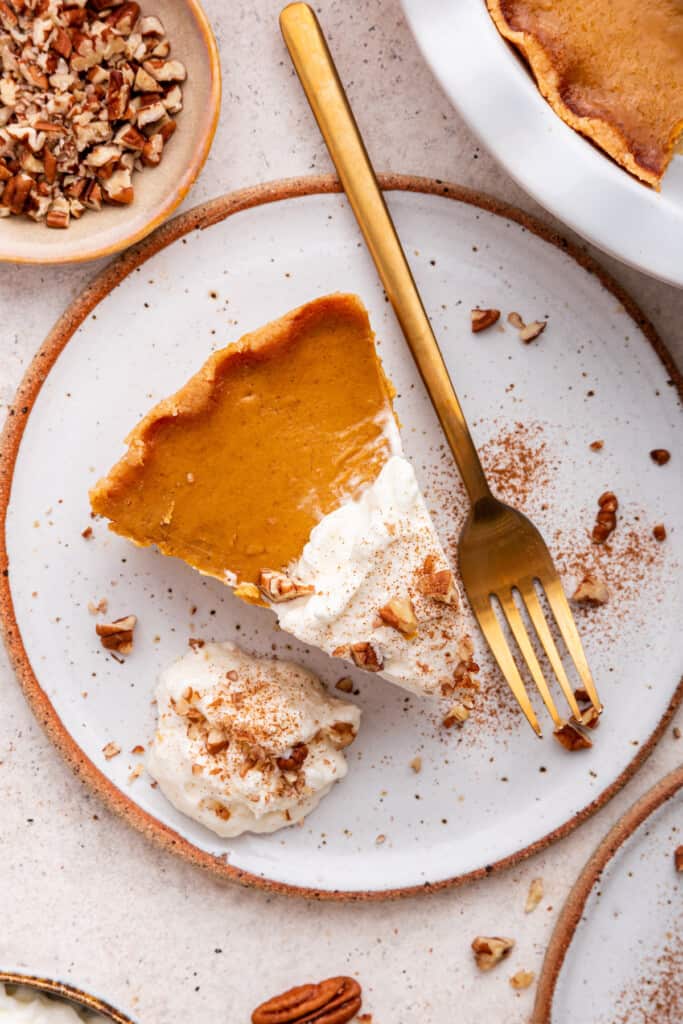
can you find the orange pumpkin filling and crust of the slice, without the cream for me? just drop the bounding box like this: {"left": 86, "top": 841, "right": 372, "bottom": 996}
{"left": 90, "top": 295, "right": 397, "bottom": 583}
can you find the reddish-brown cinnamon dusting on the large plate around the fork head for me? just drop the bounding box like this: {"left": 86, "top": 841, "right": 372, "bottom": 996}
{"left": 426, "top": 421, "right": 671, "bottom": 741}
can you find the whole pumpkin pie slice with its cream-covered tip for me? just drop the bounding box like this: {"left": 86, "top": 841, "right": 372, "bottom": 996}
{"left": 90, "top": 294, "right": 472, "bottom": 695}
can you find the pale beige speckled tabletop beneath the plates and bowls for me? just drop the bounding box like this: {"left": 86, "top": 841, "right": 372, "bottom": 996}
{"left": 0, "top": 0, "right": 683, "bottom": 1024}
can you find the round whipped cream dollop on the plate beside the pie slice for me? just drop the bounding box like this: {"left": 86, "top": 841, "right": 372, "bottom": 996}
{"left": 147, "top": 642, "right": 360, "bottom": 837}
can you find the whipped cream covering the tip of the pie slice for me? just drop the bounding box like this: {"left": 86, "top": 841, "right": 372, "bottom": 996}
{"left": 272, "top": 455, "right": 472, "bottom": 694}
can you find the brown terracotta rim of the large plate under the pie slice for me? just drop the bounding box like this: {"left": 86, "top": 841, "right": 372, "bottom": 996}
{"left": 0, "top": 174, "right": 683, "bottom": 901}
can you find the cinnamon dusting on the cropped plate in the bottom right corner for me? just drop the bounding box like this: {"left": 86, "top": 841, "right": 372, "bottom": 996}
{"left": 614, "top": 941, "right": 683, "bottom": 1024}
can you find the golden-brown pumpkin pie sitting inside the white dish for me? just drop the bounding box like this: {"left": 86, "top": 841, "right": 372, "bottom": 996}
{"left": 486, "top": 0, "right": 683, "bottom": 188}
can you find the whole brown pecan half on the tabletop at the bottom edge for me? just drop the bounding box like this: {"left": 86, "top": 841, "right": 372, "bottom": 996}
{"left": 251, "top": 978, "right": 362, "bottom": 1024}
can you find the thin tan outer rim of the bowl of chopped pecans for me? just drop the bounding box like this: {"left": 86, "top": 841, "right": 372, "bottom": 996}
{"left": 0, "top": 0, "right": 222, "bottom": 266}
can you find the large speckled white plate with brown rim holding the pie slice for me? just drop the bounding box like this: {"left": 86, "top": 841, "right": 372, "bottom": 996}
{"left": 0, "top": 178, "right": 683, "bottom": 898}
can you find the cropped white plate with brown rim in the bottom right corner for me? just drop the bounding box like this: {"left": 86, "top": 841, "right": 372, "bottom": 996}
{"left": 531, "top": 767, "right": 683, "bottom": 1024}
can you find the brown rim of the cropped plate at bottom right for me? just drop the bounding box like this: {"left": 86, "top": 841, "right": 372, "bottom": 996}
{"left": 530, "top": 765, "right": 683, "bottom": 1024}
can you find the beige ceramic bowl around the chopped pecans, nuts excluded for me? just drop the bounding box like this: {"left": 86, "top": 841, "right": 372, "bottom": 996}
{"left": 0, "top": 0, "right": 220, "bottom": 263}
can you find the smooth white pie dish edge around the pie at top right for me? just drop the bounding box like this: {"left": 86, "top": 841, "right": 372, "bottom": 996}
{"left": 402, "top": 0, "right": 683, "bottom": 287}
